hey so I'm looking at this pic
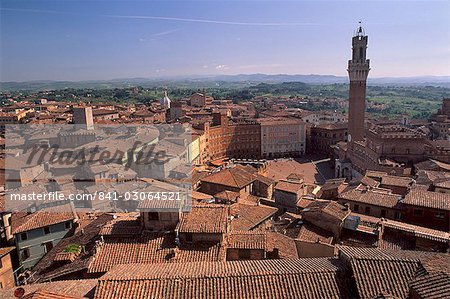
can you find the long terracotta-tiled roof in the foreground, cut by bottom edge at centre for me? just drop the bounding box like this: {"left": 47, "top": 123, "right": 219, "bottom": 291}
{"left": 94, "top": 258, "right": 352, "bottom": 299}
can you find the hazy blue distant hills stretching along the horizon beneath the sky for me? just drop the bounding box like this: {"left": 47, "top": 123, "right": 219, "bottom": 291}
{"left": 0, "top": 74, "right": 450, "bottom": 91}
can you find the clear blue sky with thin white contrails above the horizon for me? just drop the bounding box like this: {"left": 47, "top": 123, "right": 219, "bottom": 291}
{"left": 0, "top": 0, "right": 450, "bottom": 81}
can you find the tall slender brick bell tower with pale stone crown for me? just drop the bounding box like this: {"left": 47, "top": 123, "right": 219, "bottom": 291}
{"left": 347, "top": 22, "right": 370, "bottom": 141}
